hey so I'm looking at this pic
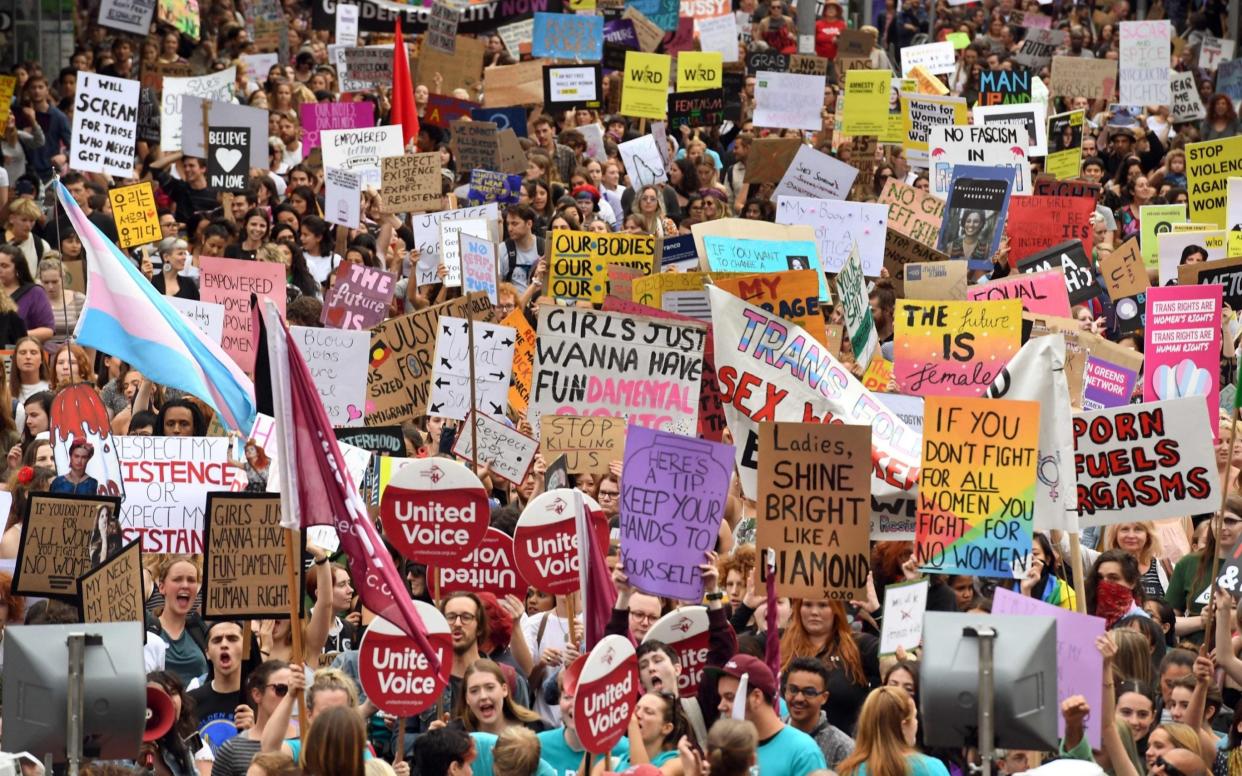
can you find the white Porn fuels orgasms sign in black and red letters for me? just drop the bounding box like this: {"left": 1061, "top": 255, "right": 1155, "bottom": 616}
{"left": 1073, "top": 396, "right": 1221, "bottom": 525}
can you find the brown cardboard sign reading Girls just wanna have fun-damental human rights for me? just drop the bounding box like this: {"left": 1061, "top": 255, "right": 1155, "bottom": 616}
{"left": 202, "top": 493, "right": 301, "bottom": 620}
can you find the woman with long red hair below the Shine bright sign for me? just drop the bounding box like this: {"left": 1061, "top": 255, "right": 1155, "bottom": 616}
{"left": 780, "top": 600, "right": 879, "bottom": 733}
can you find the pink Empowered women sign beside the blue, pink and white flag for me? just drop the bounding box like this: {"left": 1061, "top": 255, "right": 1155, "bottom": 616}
{"left": 199, "top": 256, "right": 288, "bottom": 371}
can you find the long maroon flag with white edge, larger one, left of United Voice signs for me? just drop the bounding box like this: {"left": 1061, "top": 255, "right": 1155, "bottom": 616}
{"left": 251, "top": 297, "right": 440, "bottom": 672}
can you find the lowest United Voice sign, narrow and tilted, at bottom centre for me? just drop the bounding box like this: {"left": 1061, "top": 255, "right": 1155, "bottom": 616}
{"left": 574, "top": 635, "right": 640, "bottom": 755}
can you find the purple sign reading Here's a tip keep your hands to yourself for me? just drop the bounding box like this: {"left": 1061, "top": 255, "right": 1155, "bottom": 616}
{"left": 619, "top": 426, "right": 733, "bottom": 602}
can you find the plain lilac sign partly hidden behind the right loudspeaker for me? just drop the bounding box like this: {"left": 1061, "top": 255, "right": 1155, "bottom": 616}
{"left": 992, "top": 587, "right": 1104, "bottom": 749}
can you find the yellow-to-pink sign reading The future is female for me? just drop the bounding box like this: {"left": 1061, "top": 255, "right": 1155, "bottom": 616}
{"left": 893, "top": 299, "right": 1022, "bottom": 396}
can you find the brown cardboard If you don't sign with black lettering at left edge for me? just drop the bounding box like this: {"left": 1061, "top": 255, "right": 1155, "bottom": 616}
{"left": 12, "top": 493, "right": 124, "bottom": 600}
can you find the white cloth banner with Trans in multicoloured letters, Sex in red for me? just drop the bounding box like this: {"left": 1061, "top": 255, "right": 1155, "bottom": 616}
{"left": 708, "top": 287, "right": 919, "bottom": 498}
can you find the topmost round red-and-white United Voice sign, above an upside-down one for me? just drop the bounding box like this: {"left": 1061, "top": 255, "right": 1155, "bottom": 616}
{"left": 380, "top": 458, "right": 491, "bottom": 564}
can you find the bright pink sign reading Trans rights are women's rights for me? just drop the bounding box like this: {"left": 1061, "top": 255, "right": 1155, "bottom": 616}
{"left": 1143, "top": 286, "right": 1221, "bottom": 438}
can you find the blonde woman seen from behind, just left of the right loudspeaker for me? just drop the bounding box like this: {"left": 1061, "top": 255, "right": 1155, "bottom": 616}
{"left": 837, "top": 687, "right": 949, "bottom": 776}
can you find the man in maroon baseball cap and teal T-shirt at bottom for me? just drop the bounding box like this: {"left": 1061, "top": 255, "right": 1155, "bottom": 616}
{"left": 715, "top": 654, "right": 828, "bottom": 776}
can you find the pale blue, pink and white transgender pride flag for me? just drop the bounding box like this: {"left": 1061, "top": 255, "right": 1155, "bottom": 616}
{"left": 56, "top": 181, "right": 255, "bottom": 436}
